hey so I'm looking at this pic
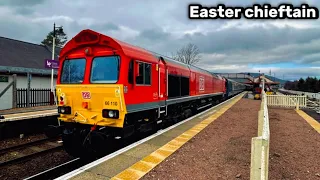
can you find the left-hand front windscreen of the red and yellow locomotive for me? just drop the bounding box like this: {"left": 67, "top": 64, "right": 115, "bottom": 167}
{"left": 60, "top": 59, "right": 86, "bottom": 84}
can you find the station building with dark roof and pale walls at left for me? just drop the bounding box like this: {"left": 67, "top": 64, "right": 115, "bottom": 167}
{"left": 0, "top": 37, "right": 60, "bottom": 110}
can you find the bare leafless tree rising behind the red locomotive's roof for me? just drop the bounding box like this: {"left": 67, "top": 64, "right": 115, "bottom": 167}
{"left": 172, "top": 43, "right": 201, "bottom": 64}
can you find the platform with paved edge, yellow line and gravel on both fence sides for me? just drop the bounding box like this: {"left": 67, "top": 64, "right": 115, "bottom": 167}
{"left": 53, "top": 91, "right": 320, "bottom": 180}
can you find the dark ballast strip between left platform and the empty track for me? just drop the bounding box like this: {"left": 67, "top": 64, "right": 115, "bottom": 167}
{"left": 0, "top": 134, "right": 46, "bottom": 149}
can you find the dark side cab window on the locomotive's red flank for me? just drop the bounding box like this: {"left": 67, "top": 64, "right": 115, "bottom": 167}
{"left": 136, "top": 62, "right": 152, "bottom": 85}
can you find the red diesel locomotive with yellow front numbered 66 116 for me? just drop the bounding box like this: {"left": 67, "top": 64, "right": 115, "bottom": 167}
{"left": 56, "top": 30, "right": 241, "bottom": 156}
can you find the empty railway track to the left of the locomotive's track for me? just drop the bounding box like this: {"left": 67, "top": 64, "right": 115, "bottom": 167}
{"left": 0, "top": 138, "right": 63, "bottom": 168}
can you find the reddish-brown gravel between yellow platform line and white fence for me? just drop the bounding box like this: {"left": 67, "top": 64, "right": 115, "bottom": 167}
{"left": 142, "top": 99, "right": 261, "bottom": 180}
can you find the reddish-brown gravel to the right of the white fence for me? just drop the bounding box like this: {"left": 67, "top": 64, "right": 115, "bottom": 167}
{"left": 269, "top": 109, "right": 320, "bottom": 180}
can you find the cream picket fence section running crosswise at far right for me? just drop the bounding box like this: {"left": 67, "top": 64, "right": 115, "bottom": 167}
{"left": 266, "top": 95, "right": 307, "bottom": 109}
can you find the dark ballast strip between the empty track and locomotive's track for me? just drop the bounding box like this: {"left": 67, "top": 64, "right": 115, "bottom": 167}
{"left": 0, "top": 150, "right": 73, "bottom": 180}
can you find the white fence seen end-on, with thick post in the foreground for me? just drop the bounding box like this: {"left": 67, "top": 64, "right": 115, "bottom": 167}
{"left": 250, "top": 91, "right": 270, "bottom": 180}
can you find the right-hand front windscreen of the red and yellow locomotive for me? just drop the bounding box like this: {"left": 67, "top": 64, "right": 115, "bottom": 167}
{"left": 90, "top": 56, "right": 120, "bottom": 83}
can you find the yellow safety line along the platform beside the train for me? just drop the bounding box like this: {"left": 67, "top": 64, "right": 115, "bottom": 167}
{"left": 111, "top": 94, "right": 244, "bottom": 180}
